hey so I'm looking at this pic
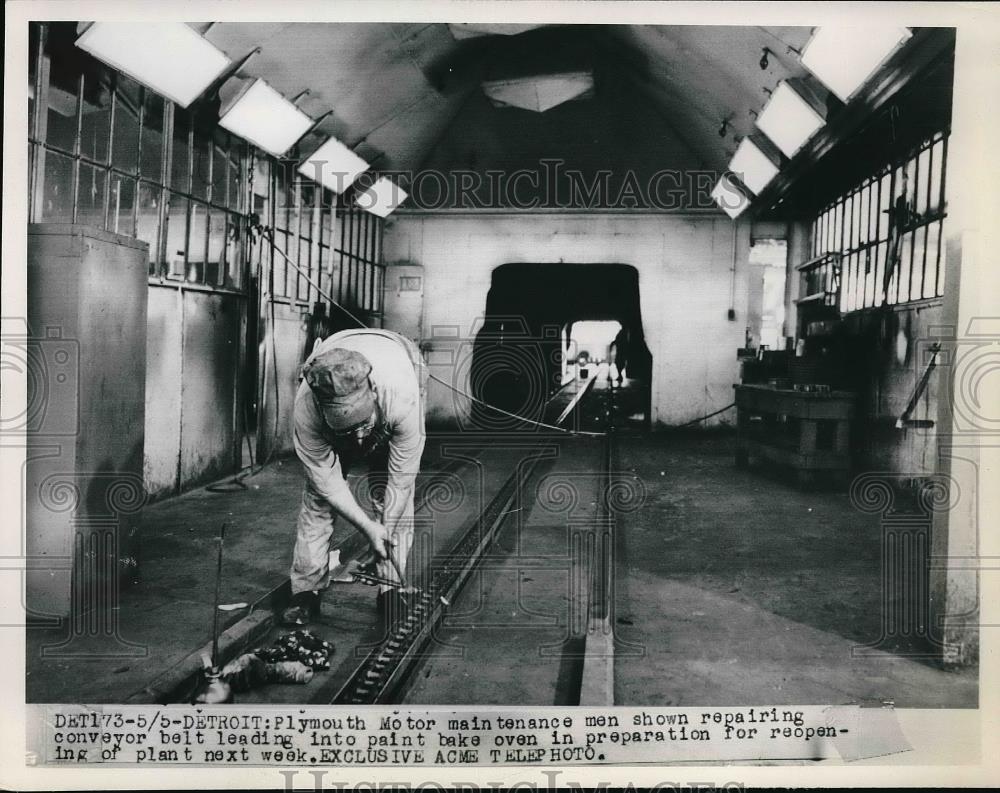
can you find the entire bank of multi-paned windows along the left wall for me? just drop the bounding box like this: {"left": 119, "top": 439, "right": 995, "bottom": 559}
{"left": 28, "top": 22, "right": 383, "bottom": 310}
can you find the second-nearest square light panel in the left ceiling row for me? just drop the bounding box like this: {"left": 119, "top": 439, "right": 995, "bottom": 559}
{"left": 219, "top": 80, "right": 313, "bottom": 157}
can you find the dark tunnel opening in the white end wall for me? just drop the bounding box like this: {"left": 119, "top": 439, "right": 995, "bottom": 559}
{"left": 470, "top": 262, "right": 652, "bottom": 429}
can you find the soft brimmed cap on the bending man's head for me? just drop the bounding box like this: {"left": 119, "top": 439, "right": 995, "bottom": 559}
{"left": 302, "top": 347, "right": 375, "bottom": 431}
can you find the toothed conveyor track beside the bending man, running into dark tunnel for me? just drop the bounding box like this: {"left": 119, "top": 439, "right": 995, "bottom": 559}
{"left": 332, "top": 377, "right": 610, "bottom": 705}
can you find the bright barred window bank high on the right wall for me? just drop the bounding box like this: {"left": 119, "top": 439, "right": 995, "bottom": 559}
{"left": 812, "top": 131, "right": 948, "bottom": 312}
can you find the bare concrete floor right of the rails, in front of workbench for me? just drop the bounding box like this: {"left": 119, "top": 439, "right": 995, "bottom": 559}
{"left": 615, "top": 432, "right": 978, "bottom": 708}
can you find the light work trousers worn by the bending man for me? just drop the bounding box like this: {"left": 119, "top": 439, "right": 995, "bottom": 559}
{"left": 291, "top": 455, "right": 415, "bottom": 595}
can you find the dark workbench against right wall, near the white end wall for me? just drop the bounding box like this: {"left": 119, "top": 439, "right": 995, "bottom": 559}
{"left": 733, "top": 385, "right": 855, "bottom": 484}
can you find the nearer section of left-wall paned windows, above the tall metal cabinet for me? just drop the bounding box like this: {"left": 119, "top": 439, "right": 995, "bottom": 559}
{"left": 28, "top": 22, "right": 248, "bottom": 290}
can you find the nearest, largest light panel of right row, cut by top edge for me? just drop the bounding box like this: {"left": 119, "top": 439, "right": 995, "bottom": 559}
{"left": 802, "top": 27, "right": 911, "bottom": 102}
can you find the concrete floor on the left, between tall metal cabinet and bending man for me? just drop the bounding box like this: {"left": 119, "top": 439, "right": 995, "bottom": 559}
{"left": 26, "top": 438, "right": 464, "bottom": 703}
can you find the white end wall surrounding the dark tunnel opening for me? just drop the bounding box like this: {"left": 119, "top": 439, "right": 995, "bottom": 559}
{"left": 385, "top": 212, "right": 750, "bottom": 425}
